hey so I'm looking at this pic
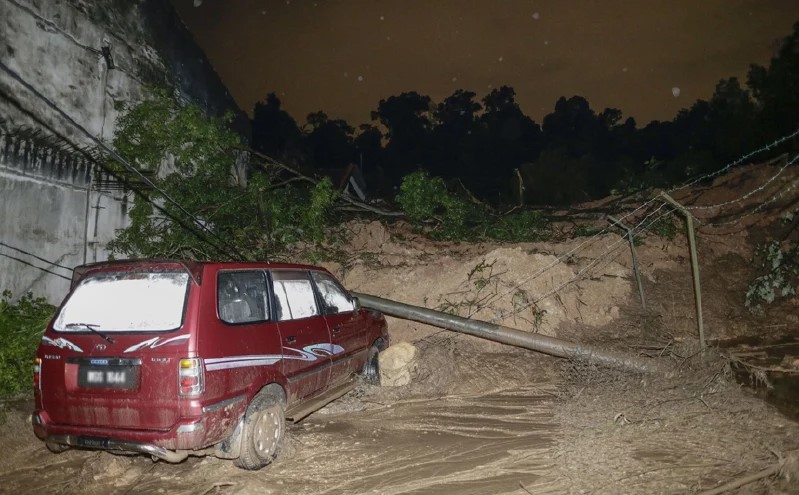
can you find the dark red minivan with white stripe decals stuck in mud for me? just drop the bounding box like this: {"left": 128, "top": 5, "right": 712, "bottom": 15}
{"left": 32, "top": 260, "right": 389, "bottom": 469}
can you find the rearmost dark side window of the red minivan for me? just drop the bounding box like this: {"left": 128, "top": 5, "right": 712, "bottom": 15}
{"left": 217, "top": 270, "right": 269, "bottom": 323}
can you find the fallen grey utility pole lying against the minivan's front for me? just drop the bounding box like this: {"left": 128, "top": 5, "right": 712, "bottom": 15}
{"left": 353, "top": 292, "right": 659, "bottom": 373}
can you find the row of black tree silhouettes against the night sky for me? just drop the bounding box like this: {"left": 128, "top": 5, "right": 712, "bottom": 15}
{"left": 245, "top": 23, "right": 799, "bottom": 205}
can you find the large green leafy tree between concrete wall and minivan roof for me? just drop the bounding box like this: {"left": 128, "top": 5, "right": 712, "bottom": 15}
{"left": 108, "top": 91, "right": 338, "bottom": 260}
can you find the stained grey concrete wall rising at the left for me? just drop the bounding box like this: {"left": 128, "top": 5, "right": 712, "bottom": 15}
{"left": 0, "top": 0, "right": 248, "bottom": 303}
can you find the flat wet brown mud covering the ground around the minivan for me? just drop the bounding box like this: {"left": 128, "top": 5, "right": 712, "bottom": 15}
{"left": 0, "top": 344, "right": 799, "bottom": 495}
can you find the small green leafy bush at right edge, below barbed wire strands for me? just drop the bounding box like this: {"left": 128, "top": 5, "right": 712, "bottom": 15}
{"left": 745, "top": 241, "right": 799, "bottom": 313}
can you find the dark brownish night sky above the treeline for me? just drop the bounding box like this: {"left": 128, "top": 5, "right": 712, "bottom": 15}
{"left": 173, "top": 0, "right": 799, "bottom": 126}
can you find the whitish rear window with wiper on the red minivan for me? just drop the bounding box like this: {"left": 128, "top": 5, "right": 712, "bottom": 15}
{"left": 53, "top": 272, "right": 189, "bottom": 333}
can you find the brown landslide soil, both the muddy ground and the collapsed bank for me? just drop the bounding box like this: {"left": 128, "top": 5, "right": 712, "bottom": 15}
{"left": 0, "top": 161, "right": 799, "bottom": 495}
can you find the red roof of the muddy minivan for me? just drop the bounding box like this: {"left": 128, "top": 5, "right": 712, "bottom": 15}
{"left": 72, "top": 258, "right": 327, "bottom": 288}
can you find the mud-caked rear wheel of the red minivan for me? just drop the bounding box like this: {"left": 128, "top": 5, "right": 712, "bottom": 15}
{"left": 233, "top": 394, "right": 286, "bottom": 471}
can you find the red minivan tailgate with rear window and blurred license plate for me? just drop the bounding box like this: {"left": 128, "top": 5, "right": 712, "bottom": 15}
{"left": 37, "top": 269, "right": 196, "bottom": 430}
